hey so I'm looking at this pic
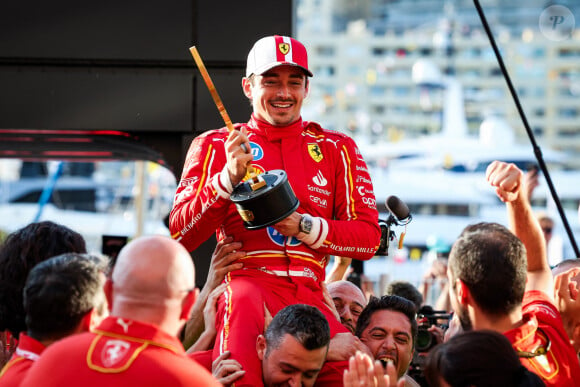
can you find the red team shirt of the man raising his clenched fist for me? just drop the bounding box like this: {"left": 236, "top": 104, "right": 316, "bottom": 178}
{"left": 504, "top": 291, "right": 580, "bottom": 386}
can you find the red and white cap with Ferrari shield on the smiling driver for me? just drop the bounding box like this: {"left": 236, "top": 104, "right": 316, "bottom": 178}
{"left": 246, "top": 35, "right": 312, "bottom": 77}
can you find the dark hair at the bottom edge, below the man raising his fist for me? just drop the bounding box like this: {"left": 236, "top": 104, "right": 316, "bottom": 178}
{"left": 423, "top": 330, "right": 544, "bottom": 387}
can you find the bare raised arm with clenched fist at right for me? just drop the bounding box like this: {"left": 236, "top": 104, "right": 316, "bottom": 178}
{"left": 486, "top": 161, "right": 554, "bottom": 300}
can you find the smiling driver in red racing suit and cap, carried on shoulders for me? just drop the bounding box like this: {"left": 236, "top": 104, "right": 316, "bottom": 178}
{"left": 170, "top": 36, "right": 380, "bottom": 386}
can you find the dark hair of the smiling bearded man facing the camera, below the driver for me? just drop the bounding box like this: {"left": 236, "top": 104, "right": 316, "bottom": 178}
{"left": 354, "top": 296, "right": 418, "bottom": 348}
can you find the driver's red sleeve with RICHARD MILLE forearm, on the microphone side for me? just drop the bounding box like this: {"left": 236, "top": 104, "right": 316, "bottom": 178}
{"left": 305, "top": 136, "right": 381, "bottom": 259}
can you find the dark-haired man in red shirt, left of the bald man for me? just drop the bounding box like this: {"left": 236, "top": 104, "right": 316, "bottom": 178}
{"left": 0, "top": 253, "right": 108, "bottom": 387}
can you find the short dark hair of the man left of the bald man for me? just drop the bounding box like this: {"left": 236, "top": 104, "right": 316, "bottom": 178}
{"left": 23, "top": 253, "right": 107, "bottom": 340}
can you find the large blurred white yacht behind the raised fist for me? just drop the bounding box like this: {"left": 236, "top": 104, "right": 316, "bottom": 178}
{"left": 359, "top": 59, "right": 580, "bottom": 290}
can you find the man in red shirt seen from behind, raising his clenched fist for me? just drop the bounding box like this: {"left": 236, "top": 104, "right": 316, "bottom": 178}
{"left": 448, "top": 161, "right": 580, "bottom": 386}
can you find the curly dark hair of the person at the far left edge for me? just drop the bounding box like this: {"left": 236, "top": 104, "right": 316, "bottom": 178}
{"left": 0, "top": 221, "right": 87, "bottom": 336}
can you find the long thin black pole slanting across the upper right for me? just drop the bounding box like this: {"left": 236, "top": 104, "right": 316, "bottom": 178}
{"left": 473, "top": 0, "right": 580, "bottom": 258}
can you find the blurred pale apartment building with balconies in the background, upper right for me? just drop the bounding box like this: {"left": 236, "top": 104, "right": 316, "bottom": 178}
{"left": 295, "top": 0, "right": 580, "bottom": 167}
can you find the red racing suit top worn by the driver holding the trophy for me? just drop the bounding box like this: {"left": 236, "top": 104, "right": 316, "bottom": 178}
{"left": 170, "top": 118, "right": 380, "bottom": 268}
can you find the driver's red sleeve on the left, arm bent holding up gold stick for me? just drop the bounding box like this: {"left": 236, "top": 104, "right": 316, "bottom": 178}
{"left": 169, "top": 129, "right": 232, "bottom": 251}
